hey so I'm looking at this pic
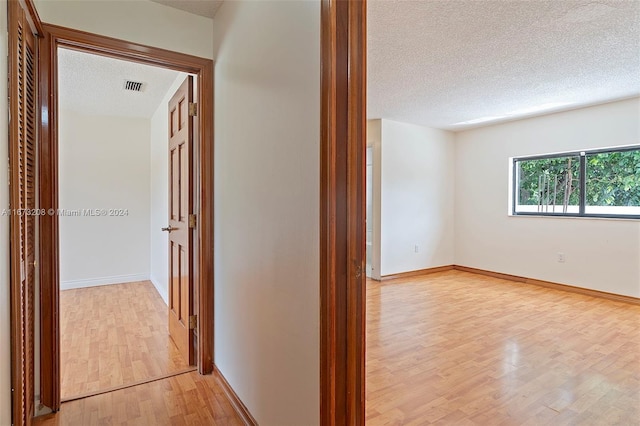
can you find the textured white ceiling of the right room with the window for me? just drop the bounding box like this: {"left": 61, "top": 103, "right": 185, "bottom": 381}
{"left": 367, "top": 0, "right": 640, "bottom": 130}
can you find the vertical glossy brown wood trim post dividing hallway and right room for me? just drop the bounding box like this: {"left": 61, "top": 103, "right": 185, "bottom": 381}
{"left": 320, "top": 0, "right": 366, "bottom": 425}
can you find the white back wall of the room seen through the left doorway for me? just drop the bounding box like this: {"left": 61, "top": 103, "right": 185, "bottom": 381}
{"left": 59, "top": 110, "right": 150, "bottom": 290}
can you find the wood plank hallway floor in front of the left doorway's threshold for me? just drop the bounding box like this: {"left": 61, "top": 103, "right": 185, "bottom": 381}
{"left": 34, "top": 372, "right": 244, "bottom": 426}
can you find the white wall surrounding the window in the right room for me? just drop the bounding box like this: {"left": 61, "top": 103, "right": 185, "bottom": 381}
{"left": 455, "top": 98, "right": 640, "bottom": 297}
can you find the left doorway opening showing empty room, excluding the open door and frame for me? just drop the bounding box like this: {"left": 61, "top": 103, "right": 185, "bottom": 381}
{"left": 57, "top": 47, "right": 197, "bottom": 402}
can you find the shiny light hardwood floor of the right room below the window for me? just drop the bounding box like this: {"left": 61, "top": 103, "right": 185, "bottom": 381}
{"left": 366, "top": 271, "right": 640, "bottom": 426}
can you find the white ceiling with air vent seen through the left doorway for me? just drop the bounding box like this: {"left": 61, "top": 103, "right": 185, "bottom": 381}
{"left": 58, "top": 49, "right": 186, "bottom": 118}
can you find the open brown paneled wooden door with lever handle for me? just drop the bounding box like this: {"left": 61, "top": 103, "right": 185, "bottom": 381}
{"left": 163, "top": 76, "right": 196, "bottom": 365}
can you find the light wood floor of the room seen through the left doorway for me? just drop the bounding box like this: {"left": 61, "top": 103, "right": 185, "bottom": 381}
{"left": 60, "top": 281, "right": 189, "bottom": 400}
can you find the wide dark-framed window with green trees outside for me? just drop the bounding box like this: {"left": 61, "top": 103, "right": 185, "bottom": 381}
{"left": 513, "top": 146, "right": 640, "bottom": 219}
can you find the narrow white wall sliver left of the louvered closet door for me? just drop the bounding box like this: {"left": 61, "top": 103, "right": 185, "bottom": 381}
{"left": 0, "top": 0, "right": 11, "bottom": 426}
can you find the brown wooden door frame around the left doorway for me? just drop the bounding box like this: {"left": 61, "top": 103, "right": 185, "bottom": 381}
{"left": 38, "top": 23, "right": 214, "bottom": 411}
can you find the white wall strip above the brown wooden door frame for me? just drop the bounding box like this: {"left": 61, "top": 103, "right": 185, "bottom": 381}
{"left": 35, "top": 0, "right": 213, "bottom": 58}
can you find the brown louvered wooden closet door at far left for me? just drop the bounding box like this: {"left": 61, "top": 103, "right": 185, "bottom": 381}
{"left": 9, "top": 2, "right": 38, "bottom": 424}
